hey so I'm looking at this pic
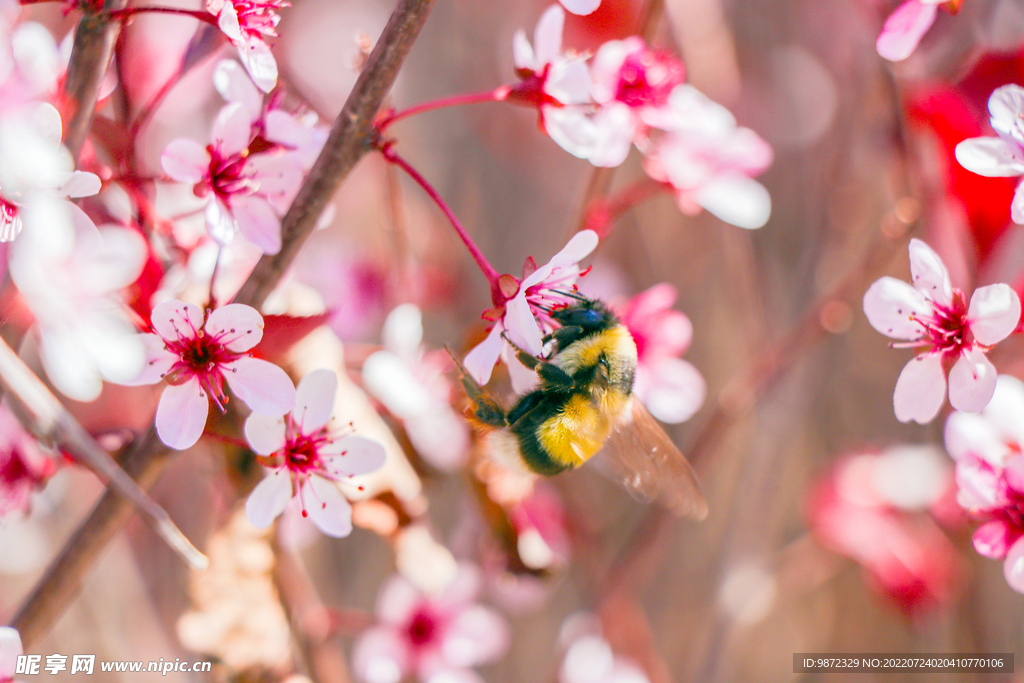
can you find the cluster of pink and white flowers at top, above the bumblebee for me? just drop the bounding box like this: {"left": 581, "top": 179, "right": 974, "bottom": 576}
{"left": 507, "top": 5, "right": 773, "bottom": 228}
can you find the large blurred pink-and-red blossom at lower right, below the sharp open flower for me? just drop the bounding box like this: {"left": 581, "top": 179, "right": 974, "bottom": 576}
{"left": 808, "top": 446, "right": 963, "bottom": 614}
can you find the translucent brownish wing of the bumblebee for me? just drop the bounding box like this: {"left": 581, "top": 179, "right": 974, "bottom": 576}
{"left": 598, "top": 397, "right": 708, "bottom": 519}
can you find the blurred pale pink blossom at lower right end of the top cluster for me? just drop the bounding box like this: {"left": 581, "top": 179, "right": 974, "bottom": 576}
{"left": 644, "top": 85, "right": 772, "bottom": 229}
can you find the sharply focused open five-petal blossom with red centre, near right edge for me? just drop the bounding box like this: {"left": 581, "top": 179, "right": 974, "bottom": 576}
{"left": 864, "top": 240, "right": 1021, "bottom": 424}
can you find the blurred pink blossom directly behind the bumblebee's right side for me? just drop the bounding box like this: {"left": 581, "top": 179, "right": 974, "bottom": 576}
{"left": 615, "top": 284, "right": 708, "bottom": 424}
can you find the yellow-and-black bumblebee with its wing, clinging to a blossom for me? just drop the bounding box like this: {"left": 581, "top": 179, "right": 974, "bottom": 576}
{"left": 450, "top": 298, "right": 708, "bottom": 519}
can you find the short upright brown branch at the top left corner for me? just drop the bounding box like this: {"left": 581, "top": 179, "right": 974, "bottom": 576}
{"left": 65, "top": 0, "right": 128, "bottom": 159}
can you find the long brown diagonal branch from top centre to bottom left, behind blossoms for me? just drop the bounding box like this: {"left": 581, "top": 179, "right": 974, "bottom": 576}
{"left": 12, "top": 0, "right": 433, "bottom": 647}
